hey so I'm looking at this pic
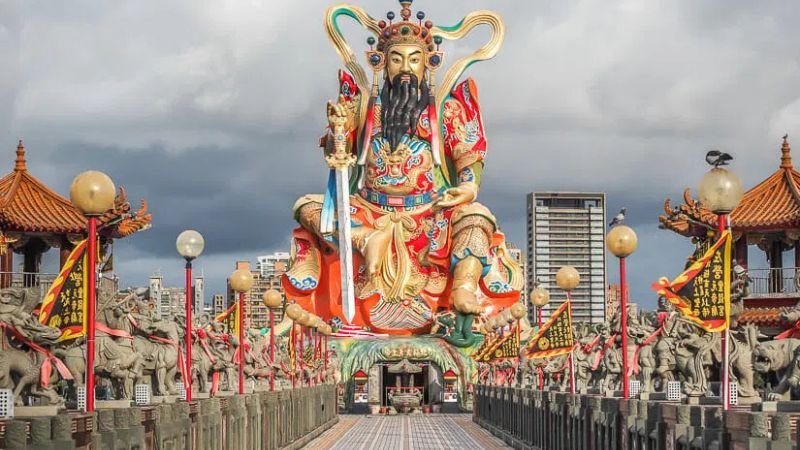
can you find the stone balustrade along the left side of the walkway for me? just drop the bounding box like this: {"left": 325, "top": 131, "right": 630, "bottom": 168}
{"left": 0, "top": 385, "right": 338, "bottom": 450}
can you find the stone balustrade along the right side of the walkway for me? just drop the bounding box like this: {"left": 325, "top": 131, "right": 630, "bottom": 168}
{"left": 473, "top": 385, "right": 800, "bottom": 450}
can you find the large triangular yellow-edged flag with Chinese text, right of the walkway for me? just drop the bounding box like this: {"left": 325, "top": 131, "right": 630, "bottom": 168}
{"left": 653, "top": 231, "right": 731, "bottom": 332}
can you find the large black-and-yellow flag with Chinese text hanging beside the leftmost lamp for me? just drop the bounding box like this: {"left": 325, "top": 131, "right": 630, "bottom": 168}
{"left": 39, "top": 241, "right": 88, "bottom": 341}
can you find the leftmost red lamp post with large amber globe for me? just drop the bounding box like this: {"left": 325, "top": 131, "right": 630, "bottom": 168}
{"left": 69, "top": 170, "right": 117, "bottom": 412}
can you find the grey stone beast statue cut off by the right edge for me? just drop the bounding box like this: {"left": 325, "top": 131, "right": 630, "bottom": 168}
{"left": 752, "top": 339, "right": 800, "bottom": 401}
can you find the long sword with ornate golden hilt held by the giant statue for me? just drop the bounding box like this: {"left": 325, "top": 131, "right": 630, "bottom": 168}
{"left": 325, "top": 114, "right": 356, "bottom": 323}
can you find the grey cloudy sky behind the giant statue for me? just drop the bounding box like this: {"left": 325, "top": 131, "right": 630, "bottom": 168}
{"left": 0, "top": 0, "right": 800, "bottom": 307}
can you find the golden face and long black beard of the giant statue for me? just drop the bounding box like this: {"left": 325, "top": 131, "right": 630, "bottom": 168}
{"left": 381, "top": 44, "right": 430, "bottom": 151}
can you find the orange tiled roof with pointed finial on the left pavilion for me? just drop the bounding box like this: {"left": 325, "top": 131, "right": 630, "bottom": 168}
{"left": 0, "top": 141, "right": 86, "bottom": 233}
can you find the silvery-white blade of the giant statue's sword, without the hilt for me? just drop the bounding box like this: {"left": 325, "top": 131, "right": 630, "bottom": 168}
{"left": 336, "top": 167, "right": 356, "bottom": 323}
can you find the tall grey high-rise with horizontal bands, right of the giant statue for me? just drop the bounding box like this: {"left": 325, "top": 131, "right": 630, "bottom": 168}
{"left": 527, "top": 192, "right": 607, "bottom": 323}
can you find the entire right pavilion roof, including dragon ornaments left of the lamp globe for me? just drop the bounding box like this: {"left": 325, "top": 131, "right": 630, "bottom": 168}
{"left": 659, "top": 135, "right": 800, "bottom": 236}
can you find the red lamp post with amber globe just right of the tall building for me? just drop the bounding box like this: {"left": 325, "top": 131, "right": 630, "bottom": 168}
{"left": 606, "top": 225, "right": 638, "bottom": 400}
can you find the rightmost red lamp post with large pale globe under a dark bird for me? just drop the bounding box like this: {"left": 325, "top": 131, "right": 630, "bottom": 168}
{"left": 698, "top": 166, "right": 744, "bottom": 411}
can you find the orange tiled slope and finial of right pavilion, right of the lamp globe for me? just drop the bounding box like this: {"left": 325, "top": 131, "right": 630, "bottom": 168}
{"left": 731, "top": 136, "right": 800, "bottom": 231}
